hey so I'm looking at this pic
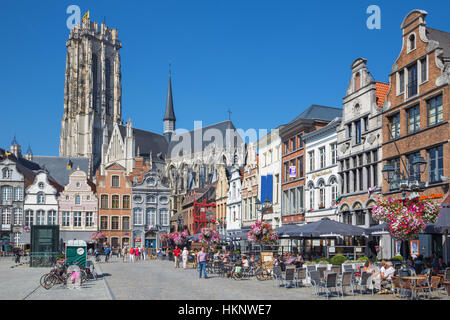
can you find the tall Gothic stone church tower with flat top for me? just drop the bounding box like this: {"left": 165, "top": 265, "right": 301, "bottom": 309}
{"left": 59, "top": 19, "right": 122, "bottom": 173}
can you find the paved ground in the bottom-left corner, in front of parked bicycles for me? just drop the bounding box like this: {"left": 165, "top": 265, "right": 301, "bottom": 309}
{"left": 0, "top": 258, "right": 111, "bottom": 300}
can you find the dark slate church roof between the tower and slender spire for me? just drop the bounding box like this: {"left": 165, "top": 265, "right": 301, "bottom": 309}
{"left": 119, "top": 125, "right": 167, "bottom": 162}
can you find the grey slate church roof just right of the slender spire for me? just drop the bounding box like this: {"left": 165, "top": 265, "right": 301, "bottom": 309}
{"left": 168, "top": 120, "right": 243, "bottom": 157}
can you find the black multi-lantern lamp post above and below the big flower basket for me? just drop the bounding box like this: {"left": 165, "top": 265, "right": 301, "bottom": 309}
{"left": 381, "top": 156, "right": 427, "bottom": 262}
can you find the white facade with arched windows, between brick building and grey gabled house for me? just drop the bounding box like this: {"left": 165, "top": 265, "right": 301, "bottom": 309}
{"left": 303, "top": 118, "right": 341, "bottom": 223}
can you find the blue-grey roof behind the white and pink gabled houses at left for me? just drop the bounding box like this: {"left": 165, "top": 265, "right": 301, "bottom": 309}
{"left": 33, "top": 156, "right": 92, "bottom": 187}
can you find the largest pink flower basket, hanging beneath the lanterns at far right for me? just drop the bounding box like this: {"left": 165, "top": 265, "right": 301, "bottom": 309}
{"left": 372, "top": 197, "right": 440, "bottom": 240}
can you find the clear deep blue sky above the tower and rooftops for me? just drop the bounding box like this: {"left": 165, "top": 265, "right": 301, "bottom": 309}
{"left": 0, "top": 0, "right": 450, "bottom": 155}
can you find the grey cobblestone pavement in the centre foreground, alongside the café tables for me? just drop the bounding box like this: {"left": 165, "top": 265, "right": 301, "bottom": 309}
{"left": 101, "top": 260, "right": 400, "bottom": 300}
